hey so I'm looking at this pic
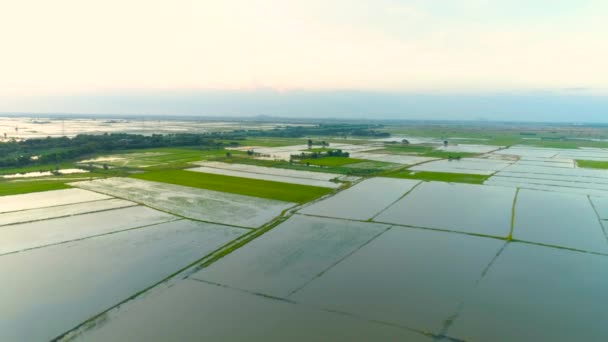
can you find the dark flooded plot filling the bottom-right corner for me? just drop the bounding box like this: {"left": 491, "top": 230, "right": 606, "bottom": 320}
{"left": 447, "top": 243, "right": 608, "bottom": 341}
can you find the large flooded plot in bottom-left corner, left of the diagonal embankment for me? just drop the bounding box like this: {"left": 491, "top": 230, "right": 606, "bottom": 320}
{"left": 0, "top": 220, "right": 247, "bottom": 341}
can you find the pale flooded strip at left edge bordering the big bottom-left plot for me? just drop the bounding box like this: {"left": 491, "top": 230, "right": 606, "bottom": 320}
{"left": 0, "top": 206, "right": 176, "bottom": 255}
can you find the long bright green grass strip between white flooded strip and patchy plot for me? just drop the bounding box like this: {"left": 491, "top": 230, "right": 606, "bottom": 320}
{"left": 131, "top": 170, "right": 333, "bottom": 203}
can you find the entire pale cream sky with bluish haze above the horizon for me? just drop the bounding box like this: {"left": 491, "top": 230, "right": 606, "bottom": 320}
{"left": 0, "top": 0, "right": 608, "bottom": 121}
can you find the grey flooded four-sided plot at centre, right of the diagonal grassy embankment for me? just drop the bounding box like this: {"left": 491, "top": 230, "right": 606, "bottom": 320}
{"left": 192, "top": 215, "right": 388, "bottom": 297}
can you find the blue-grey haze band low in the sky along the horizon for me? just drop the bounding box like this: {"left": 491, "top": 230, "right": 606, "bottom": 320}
{"left": 0, "top": 90, "right": 608, "bottom": 123}
